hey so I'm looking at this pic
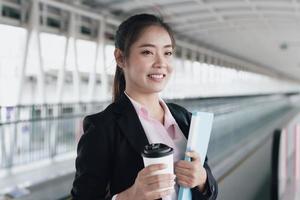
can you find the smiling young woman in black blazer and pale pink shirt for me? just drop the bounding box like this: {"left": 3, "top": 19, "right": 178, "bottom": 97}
{"left": 71, "top": 14, "right": 218, "bottom": 200}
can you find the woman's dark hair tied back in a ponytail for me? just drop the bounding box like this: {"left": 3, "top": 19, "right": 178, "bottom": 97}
{"left": 113, "top": 14, "right": 175, "bottom": 102}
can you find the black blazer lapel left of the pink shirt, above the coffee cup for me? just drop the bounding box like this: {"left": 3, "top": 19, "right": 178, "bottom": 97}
{"left": 115, "top": 94, "right": 149, "bottom": 154}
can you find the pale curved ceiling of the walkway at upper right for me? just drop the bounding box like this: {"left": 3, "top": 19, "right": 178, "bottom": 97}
{"left": 69, "top": 0, "right": 300, "bottom": 80}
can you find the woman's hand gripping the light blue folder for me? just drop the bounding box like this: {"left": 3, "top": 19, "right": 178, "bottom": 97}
{"left": 175, "top": 151, "right": 207, "bottom": 192}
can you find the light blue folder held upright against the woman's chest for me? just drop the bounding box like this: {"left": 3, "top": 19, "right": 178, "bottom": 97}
{"left": 178, "top": 112, "right": 214, "bottom": 200}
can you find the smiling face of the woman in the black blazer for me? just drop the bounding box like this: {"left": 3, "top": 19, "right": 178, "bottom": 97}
{"left": 123, "top": 26, "right": 173, "bottom": 94}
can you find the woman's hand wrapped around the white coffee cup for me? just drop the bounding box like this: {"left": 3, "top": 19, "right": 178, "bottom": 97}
{"left": 131, "top": 164, "right": 176, "bottom": 200}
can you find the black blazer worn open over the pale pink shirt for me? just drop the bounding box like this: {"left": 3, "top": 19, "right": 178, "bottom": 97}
{"left": 71, "top": 94, "right": 218, "bottom": 200}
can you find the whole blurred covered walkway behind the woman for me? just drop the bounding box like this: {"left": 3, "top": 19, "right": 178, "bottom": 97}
{"left": 0, "top": 0, "right": 300, "bottom": 200}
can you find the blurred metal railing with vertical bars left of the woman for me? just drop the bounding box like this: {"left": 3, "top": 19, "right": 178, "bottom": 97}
{"left": 0, "top": 102, "right": 107, "bottom": 169}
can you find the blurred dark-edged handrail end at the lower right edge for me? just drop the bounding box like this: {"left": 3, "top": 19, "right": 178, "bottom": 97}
{"left": 271, "top": 112, "right": 300, "bottom": 200}
